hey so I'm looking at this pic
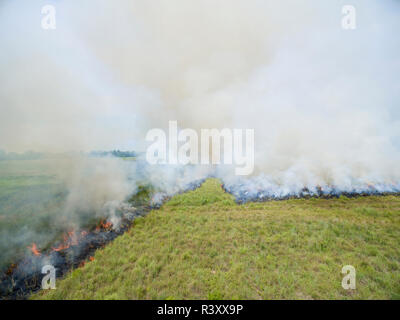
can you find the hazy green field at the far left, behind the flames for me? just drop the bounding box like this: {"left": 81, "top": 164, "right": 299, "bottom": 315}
{"left": 0, "top": 159, "right": 66, "bottom": 270}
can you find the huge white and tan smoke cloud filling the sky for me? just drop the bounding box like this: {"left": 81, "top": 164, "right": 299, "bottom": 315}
{"left": 0, "top": 0, "right": 400, "bottom": 192}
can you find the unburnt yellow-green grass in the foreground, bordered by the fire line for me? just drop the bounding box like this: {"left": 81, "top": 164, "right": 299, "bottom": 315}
{"left": 33, "top": 179, "right": 400, "bottom": 299}
